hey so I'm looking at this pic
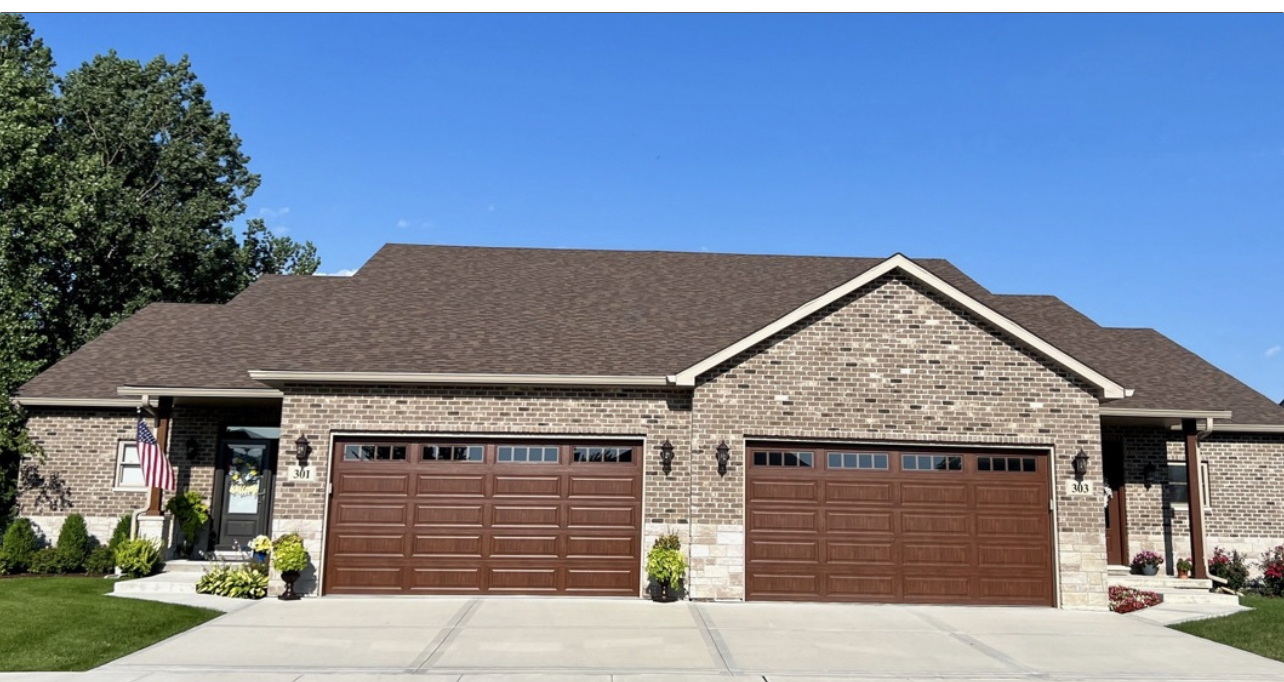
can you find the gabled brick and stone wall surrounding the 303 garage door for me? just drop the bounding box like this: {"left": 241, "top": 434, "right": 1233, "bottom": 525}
{"left": 691, "top": 275, "right": 1106, "bottom": 609}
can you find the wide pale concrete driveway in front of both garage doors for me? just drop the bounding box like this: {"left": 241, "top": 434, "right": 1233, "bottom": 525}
{"left": 10, "top": 597, "right": 1284, "bottom": 682}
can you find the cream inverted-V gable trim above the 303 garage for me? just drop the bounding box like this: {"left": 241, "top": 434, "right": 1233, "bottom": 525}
{"left": 675, "top": 253, "right": 1127, "bottom": 399}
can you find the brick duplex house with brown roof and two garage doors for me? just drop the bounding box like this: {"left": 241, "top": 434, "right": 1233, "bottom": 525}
{"left": 14, "top": 244, "right": 1284, "bottom": 609}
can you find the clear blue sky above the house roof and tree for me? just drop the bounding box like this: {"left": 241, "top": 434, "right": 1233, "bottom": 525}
{"left": 20, "top": 14, "right": 1284, "bottom": 401}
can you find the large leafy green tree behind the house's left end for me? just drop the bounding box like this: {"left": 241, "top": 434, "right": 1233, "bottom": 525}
{"left": 0, "top": 14, "right": 320, "bottom": 527}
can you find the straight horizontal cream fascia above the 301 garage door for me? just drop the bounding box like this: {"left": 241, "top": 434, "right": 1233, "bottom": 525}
{"left": 249, "top": 370, "right": 672, "bottom": 387}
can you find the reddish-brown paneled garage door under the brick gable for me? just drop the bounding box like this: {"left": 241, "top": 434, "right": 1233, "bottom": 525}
{"left": 746, "top": 443, "right": 1054, "bottom": 606}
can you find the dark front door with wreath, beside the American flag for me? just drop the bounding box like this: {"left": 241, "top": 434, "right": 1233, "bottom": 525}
{"left": 214, "top": 439, "right": 276, "bottom": 550}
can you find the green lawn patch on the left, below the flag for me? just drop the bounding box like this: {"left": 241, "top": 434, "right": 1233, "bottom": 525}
{"left": 0, "top": 577, "right": 220, "bottom": 672}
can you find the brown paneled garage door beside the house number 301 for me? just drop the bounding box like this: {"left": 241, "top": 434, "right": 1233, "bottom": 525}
{"left": 325, "top": 439, "right": 642, "bottom": 596}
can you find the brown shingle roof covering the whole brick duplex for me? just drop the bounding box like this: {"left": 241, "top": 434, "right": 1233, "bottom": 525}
{"left": 19, "top": 244, "right": 1284, "bottom": 424}
